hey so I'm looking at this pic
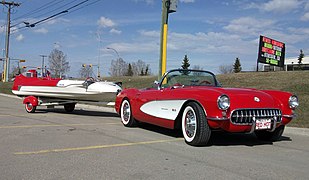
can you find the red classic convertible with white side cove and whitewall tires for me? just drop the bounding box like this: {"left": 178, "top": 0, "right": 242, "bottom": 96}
{"left": 115, "top": 69, "right": 298, "bottom": 146}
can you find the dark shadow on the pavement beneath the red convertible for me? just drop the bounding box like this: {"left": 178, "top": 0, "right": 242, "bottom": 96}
{"left": 136, "top": 123, "right": 292, "bottom": 147}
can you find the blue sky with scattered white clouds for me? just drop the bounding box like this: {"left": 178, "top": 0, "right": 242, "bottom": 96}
{"left": 0, "top": 0, "right": 309, "bottom": 77}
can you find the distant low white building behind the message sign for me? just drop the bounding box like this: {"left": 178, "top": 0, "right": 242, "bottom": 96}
{"left": 263, "top": 57, "right": 309, "bottom": 71}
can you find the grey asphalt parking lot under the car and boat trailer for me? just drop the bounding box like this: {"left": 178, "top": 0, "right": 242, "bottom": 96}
{"left": 0, "top": 95, "right": 309, "bottom": 180}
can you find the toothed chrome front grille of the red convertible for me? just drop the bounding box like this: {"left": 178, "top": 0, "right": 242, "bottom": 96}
{"left": 231, "top": 109, "right": 282, "bottom": 125}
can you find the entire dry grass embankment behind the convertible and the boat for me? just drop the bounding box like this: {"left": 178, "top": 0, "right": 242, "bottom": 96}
{"left": 0, "top": 71, "right": 309, "bottom": 128}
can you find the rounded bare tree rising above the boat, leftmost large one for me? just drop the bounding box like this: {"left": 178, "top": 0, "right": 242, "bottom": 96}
{"left": 48, "top": 49, "right": 70, "bottom": 77}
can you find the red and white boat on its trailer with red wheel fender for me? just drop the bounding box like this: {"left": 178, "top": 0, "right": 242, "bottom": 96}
{"left": 12, "top": 70, "right": 122, "bottom": 112}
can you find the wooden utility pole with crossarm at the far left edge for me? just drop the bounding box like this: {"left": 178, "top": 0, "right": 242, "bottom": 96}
{"left": 0, "top": 0, "right": 20, "bottom": 82}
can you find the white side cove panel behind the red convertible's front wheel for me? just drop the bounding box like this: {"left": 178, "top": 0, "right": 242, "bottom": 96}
{"left": 140, "top": 100, "right": 186, "bottom": 120}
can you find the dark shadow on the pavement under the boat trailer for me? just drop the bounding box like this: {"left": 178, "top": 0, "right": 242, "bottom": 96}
{"left": 35, "top": 108, "right": 119, "bottom": 117}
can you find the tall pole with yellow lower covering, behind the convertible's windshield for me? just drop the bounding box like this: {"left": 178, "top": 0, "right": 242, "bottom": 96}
{"left": 158, "top": 0, "right": 178, "bottom": 80}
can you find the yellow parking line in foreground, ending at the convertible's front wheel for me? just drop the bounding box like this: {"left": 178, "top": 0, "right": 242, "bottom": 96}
{"left": 14, "top": 138, "right": 183, "bottom": 155}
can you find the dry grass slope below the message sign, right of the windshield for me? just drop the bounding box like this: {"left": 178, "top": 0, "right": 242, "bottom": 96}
{"left": 217, "top": 71, "right": 309, "bottom": 128}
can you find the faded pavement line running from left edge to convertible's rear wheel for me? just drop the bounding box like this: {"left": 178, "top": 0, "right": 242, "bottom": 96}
{"left": 0, "top": 123, "right": 120, "bottom": 129}
